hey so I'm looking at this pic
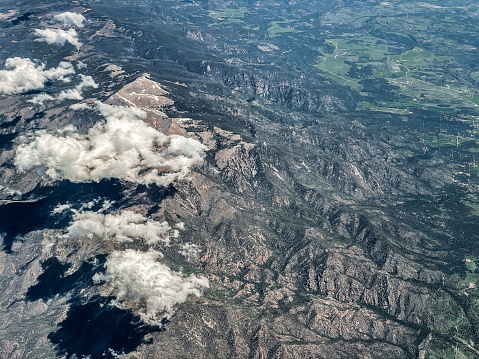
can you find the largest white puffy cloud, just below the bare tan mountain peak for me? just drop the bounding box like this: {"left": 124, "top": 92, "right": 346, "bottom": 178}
{"left": 15, "top": 102, "right": 207, "bottom": 186}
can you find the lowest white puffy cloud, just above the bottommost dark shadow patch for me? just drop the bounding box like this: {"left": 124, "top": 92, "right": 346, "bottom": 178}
{"left": 93, "top": 249, "right": 209, "bottom": 324}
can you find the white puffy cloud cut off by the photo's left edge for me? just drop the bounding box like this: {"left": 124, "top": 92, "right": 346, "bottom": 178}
{"left": 0, "top": 57, "right": 75, "bottom": 94}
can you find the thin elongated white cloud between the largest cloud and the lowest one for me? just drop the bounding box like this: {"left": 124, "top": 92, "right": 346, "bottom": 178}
{"left": 68, "top": 210, "right": 177, "bottom": 244}
